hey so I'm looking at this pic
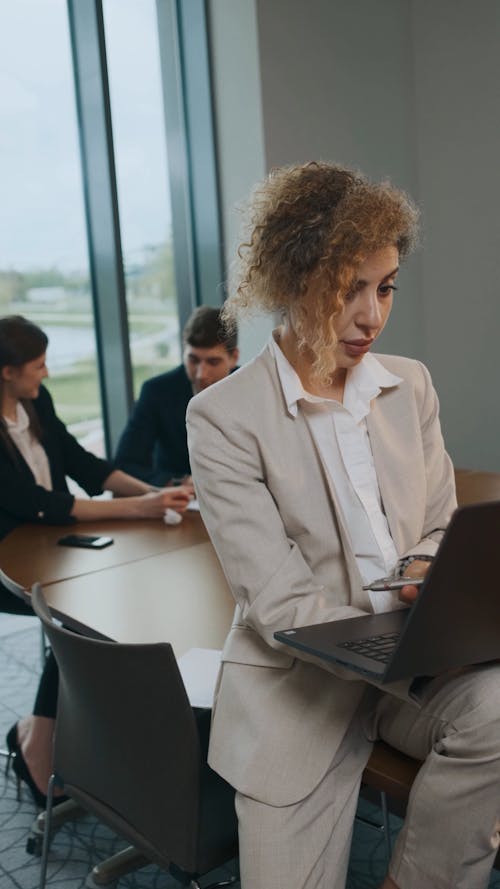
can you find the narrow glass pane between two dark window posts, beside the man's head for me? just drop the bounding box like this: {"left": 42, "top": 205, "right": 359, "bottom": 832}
{"left": 103, "top": 0, "right": 180, "bottom": 395}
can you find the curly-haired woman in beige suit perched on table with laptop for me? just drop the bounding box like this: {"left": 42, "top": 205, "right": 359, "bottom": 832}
{"left": 188, "top": 163, "right": 500, "bottom": 889}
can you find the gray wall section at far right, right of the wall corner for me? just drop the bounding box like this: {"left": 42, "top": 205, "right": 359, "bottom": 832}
{"left": 413, "top": 0, "right": 500, "bottom": 470}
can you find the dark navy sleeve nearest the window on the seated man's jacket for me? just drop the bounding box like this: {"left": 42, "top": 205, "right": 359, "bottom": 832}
{"left": 114, "top": 381, "right": 172, "bottom": 487}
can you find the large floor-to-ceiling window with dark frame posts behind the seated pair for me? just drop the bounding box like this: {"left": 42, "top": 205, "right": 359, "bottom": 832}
{"left": 0, "top": 0, "right": 222, "bottom": 455}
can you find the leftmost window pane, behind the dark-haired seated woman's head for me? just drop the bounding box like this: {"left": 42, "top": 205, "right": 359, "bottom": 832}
{"left": 0, "top": 0, "right": 103, "bottom": 454}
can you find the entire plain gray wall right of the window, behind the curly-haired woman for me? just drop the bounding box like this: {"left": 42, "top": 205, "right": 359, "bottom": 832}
{"left": 210, "top": 0, "right": 500, "bottom": 469}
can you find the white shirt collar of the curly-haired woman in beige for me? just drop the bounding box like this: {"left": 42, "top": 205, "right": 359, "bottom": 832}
{"left": 270, "top": 331, "right": 402, "bottom": 422}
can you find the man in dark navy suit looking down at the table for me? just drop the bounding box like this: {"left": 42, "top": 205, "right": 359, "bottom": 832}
{"left": 114, "top": 306, "right": 239, "bottom": 487}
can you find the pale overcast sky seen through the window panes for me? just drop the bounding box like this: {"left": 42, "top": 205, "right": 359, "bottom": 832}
{"left": 0, "top": 0, "right": 171, "bottom": 271}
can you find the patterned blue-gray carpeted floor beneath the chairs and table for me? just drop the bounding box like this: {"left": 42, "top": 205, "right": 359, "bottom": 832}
{"left": 0, "top": 614, "right": 500, "bottom": 889}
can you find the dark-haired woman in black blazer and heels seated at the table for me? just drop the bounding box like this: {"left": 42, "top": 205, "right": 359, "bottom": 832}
{"left": 0, "top": 315, "right": 192, "bottom": 806}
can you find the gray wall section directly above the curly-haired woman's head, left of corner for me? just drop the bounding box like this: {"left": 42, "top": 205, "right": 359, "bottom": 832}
{"left": 257, "top": 0, "right": 423, "bottom": 364}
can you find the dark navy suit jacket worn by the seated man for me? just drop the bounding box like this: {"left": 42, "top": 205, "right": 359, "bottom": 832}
{"left": 114, "top": 364, "right": 193, "bottom": 486}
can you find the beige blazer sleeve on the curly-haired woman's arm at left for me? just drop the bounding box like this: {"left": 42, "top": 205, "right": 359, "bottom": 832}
{"left": 187, "top": 393, "right": 364, "bottom": 664}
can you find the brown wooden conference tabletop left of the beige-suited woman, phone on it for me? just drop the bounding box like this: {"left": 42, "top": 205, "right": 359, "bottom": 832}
{"left": 0, "top": 511, "right": 234, "bottom": 658}
